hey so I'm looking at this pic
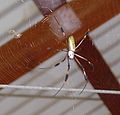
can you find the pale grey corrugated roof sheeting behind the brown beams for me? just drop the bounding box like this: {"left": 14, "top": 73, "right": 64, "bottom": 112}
{"left": 0, "top": 0, "right": 120, "bottom": 115}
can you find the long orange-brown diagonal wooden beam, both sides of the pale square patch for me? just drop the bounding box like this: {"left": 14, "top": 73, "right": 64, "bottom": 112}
{"left": 0, "top": 0, "right": 120, "bottom": 83}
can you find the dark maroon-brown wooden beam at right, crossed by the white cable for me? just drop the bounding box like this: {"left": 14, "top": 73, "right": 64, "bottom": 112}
{"left": 77, "top": 38, "right": 120, "bottom": 115}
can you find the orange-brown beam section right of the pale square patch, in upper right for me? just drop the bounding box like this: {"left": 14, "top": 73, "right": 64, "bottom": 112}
{"left": 70, "top": 0, "right": 120, "bottom": 39}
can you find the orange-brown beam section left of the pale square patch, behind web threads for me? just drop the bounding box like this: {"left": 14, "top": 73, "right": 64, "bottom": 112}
{"left": 0, "top": 23, "right": 65, "bottom": 84}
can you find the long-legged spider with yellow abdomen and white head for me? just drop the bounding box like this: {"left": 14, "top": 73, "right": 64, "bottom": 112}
{"left": 40, "top": 30, "right": 94, "bottom": 96}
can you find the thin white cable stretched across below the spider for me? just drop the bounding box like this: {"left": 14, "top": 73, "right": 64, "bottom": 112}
{"left": 0, "top": 84, "right": 120, "bottom": 95}
